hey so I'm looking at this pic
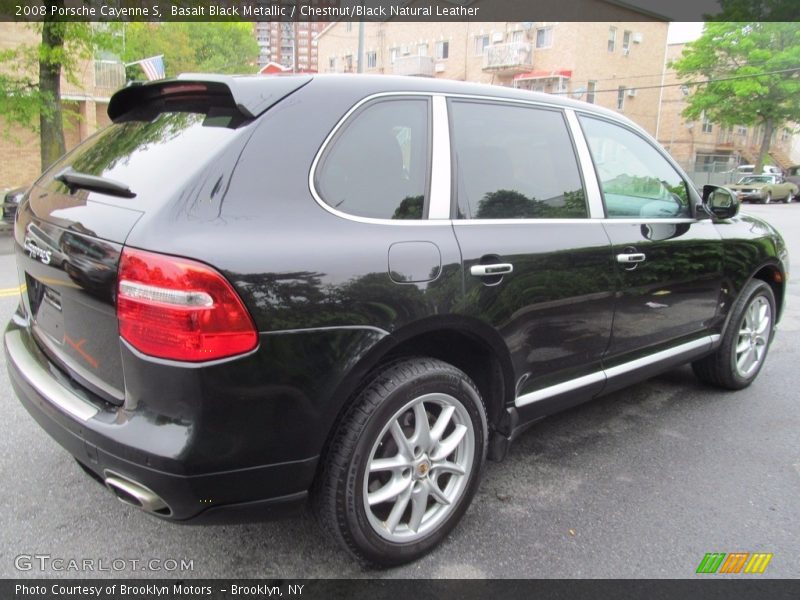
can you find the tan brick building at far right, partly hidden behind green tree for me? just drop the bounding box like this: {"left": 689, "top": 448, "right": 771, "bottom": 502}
{"left": 658, "top": 44, "right": 795, "bottom": 173}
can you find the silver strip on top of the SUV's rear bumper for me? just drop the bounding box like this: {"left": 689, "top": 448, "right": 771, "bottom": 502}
{"left": 5, "top": 331, "right": 100, "bottom": 421}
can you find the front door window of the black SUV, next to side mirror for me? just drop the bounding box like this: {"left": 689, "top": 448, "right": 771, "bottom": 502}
{"left": 580, "top": 116, "right": 691, "bottom": 219}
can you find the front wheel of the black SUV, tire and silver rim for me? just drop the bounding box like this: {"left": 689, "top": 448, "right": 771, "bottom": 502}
{"left": 692, "top": 279, "right": 776, "bottom": 390}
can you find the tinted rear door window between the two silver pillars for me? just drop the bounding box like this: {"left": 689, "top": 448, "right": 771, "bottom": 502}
{"left": 450, "top": 100, "right": 588, "bottom": 219}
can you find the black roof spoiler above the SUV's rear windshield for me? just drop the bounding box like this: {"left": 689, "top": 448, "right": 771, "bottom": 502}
{"left": 108, "top": 73, "right": 312, "bottom": 121}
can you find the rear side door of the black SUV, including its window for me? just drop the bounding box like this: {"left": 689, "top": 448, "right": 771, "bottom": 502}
{"left": 448, "top": 98, "right": 614, "bottom": 419}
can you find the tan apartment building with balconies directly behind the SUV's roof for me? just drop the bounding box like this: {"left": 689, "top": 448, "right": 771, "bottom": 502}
{"left": 317, "top": 10, "right": 668, "bottom": 134}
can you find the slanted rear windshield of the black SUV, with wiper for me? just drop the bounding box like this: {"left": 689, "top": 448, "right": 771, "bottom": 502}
{"left": 39, "top": 103, "right": 245, "bottom": 211}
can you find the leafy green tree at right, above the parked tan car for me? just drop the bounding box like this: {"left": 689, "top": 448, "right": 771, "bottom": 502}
{"left": 672, "top": 22, "right": 800, "bottom": 172}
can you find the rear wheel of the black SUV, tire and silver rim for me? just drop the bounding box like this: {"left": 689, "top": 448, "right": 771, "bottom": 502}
{"left": 312, "top": 358, "right": 487, "bottom": 566}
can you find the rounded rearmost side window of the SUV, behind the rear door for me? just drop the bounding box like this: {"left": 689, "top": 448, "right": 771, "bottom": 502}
{"left": 315, "top": 99, "right": 430, "bottom": 219}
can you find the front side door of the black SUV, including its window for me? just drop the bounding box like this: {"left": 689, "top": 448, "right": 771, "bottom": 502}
{"left": 580, "top": 115, "right": 723, "bottom": 390}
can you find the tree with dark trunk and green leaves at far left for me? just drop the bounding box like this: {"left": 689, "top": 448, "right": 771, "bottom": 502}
{"left": 0, "top": 12, "right": 113, "bottom": 170}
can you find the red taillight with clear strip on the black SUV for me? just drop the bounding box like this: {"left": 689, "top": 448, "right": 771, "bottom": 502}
{"left": 117, "top": 248, "right": 258, "bottom": 362}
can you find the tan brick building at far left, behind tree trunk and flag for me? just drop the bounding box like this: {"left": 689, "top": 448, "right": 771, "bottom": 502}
{"left": 0, "top": 23, "right": 125, "bottom": 190}
